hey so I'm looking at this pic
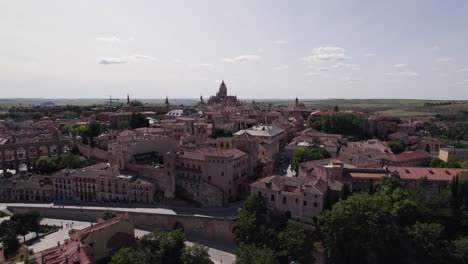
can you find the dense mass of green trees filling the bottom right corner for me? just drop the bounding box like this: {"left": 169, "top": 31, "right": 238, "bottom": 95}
{"left": 319, "top": 177, "right": 468, "bottom": 264}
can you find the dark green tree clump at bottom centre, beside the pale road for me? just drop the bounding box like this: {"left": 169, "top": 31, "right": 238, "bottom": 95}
{"left": 234, "top": 195, "right": 312, "bottom": 264}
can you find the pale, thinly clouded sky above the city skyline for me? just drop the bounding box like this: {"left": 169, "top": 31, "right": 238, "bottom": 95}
{"left": 0, "top": 0, "right": 468, "bottom": 100}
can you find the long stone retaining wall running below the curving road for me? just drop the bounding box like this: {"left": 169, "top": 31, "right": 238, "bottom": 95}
{"left": 8, "top": 206, "right": 234, "bottom": 246}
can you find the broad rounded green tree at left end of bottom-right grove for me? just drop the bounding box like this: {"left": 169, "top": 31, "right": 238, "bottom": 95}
{"left": 319, "top": 194, "right": 400, "bottom": 263}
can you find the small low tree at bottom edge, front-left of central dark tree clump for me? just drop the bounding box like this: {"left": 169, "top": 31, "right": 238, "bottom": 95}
{"left": 235, "top": 244, "right": 278, "bottom": 264}
